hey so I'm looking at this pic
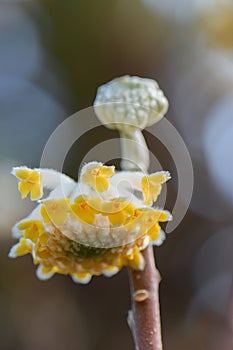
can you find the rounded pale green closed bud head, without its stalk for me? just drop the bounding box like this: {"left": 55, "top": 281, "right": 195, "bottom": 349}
{"left": 94, "top": 75, "right": 168, "bottom": 131}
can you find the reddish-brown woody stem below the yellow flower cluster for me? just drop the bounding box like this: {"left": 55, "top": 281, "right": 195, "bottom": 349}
{"left": 128, "top": 245, "right": 163, "bottom": 350}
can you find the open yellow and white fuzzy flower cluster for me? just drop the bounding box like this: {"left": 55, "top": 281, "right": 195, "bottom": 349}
{"left": 9, "top": 162, "right": 171, "bottom": 283}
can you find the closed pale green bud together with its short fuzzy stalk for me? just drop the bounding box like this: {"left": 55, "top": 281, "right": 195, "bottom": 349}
{"left": 94, "top": 75, "right": 168, "bottom": 171}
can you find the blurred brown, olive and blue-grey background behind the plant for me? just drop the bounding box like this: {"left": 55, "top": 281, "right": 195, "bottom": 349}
{"left": 0, "top": 0, "right": 233, "bottom": 350}
